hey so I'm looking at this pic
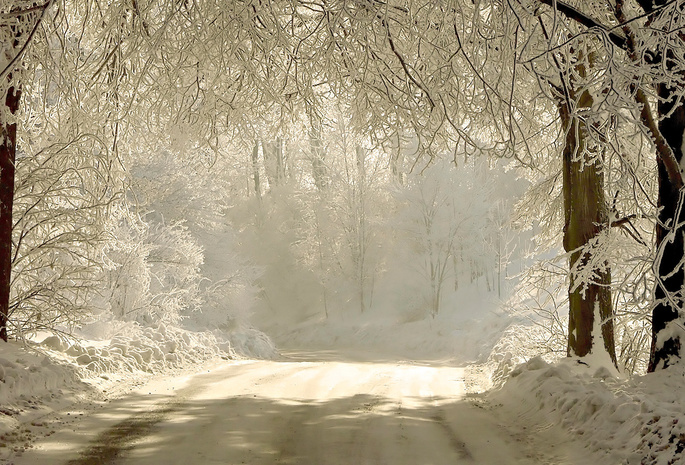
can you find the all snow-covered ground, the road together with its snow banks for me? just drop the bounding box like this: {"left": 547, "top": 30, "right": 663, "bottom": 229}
{"left": 0, "top": 300, "right": 685, "bottom": 465}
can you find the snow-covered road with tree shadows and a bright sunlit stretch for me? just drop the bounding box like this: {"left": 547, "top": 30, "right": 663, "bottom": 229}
{"left": 13, "top": 353, "right": 590, "bottom": 465}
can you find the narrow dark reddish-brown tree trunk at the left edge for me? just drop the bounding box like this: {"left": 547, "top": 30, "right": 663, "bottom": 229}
{"left": 0, "top": 86, "right": 21, "bottom": 341}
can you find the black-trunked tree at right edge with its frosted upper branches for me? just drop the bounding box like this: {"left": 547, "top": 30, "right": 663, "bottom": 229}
{"left": 502, "top": 1, "right": 685, "bottom": 370}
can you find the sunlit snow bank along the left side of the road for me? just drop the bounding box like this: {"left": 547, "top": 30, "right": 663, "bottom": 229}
{"left": 0, "top": 323, "right": 277, "bottom": 462}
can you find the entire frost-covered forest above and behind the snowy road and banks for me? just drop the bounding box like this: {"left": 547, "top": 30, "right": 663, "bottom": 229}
{"left": 0, "top": 0, "right": 685, "bottom": 463}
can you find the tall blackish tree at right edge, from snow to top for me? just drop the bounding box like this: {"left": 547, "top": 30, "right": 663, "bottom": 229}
{"left": 628, "top": 0, "right": 685, "bottom": 371}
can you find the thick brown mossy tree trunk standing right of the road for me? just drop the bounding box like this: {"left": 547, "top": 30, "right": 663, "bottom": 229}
{"left": 559, "top": 91, "right": 616, "bottom": 364}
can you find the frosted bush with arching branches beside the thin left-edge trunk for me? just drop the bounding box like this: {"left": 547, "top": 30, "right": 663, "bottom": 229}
{"left": 9, "top": 134, "right": 117, "bottom": 334}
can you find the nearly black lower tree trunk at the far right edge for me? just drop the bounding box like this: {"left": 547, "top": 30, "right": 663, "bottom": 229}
{"left": 648, "top": 85, "right": 685, "bottom": 372}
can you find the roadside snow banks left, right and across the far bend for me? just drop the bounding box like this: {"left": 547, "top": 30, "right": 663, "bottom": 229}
{"left": 8, "top": 300, "right": 685, "bottom": 465}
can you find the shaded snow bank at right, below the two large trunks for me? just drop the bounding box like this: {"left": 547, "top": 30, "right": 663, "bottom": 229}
{"left": 490, "top": 357, "right": 685, "bottom": 465}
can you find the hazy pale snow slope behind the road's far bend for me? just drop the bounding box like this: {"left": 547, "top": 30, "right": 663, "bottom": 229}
{"left": 255, "top": 274, "right": 523, "bottom": 365}
